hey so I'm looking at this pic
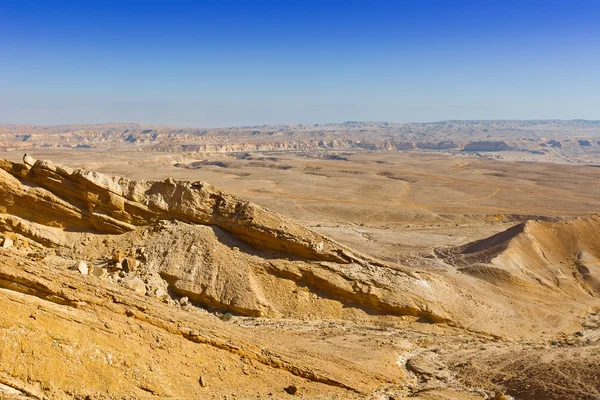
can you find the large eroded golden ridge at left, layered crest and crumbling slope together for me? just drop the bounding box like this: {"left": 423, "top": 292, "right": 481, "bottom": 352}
{"left": 0, "top": 157, "right": 451, "bottom": 321}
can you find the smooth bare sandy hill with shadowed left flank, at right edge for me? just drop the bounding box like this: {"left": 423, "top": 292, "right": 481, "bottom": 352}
{"left": 437, "top": 215, "right": 600, "bottom": 298}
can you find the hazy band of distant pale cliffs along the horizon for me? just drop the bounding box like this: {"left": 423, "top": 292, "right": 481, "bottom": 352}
{"left": 0, "top": 120, "right": 600, "bottom": 161}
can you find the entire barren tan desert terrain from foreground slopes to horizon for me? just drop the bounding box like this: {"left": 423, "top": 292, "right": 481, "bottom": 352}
{"left": 0, "top": 120, "right": 600, "bottom": 400}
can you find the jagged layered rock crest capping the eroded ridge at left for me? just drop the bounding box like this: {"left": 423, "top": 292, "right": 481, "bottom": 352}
{"left": 0, "top": 157, "right": 370, "bottom": 262}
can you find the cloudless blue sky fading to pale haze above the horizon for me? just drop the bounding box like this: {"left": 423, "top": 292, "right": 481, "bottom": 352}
{"left": 0, "top": 0, "right": 600, "bottom": 127}
